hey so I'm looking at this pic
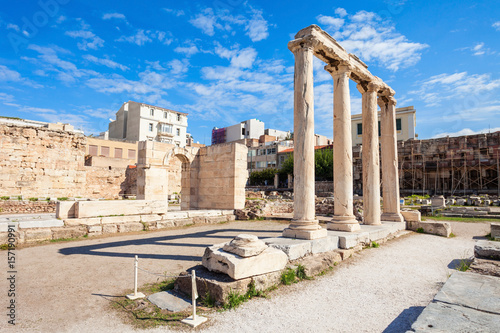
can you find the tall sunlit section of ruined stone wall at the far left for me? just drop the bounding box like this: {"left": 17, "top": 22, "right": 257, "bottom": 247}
{"left": 0, "top": 124, "right": 86, "bottom": 197}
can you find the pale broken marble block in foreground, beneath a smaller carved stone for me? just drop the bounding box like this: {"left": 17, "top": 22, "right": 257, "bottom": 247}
{"left": 202, "top": 244, "right": 288, "bottom": 280}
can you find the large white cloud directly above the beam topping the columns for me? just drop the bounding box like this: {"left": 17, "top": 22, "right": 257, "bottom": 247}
{"left": 316, "top": 8, "right": 428, "bottom": 71}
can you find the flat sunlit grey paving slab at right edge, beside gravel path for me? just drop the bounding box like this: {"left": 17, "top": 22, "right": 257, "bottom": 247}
{"left": 434, "top": 272, "right": 500, "bottom": 314}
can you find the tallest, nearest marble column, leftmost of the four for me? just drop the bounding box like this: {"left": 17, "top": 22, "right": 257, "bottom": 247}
{"left": 283, "top": 42, "right": 327, "bottom": 239}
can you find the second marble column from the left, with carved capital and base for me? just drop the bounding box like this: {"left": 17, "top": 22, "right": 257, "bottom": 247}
{"left": 325, "top": 64, "right": 360, "bottom": 231}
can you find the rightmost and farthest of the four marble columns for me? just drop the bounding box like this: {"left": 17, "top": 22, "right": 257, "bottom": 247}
{"left": 378, "top": 96, "right": 403, "bottom": 222}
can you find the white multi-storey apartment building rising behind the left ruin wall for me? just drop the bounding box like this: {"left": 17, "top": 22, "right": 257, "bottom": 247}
{"left": 108, "top": 101, "right": 187, "bottom": 147}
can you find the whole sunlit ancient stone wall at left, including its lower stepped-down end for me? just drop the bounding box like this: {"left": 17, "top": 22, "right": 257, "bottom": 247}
{"left": 0, "top": 124, "right": 136, "bottom": 199}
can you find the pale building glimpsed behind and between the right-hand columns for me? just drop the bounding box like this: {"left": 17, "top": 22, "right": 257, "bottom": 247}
{"left": 351, "top": 106, "right": 417, "bottom": 146}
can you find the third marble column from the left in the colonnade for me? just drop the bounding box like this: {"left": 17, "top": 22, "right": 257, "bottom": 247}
{"left": 358, "top": 82, "right": 381, "bottom": 225}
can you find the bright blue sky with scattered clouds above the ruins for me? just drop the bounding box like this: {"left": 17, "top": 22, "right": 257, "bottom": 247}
{"left": 0, "top": 0, "right": 500, "bottom": 144}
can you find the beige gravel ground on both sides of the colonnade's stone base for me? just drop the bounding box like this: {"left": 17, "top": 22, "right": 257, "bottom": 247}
{"left": 0, "top": 222, "right": 489, "bottom": 333}
